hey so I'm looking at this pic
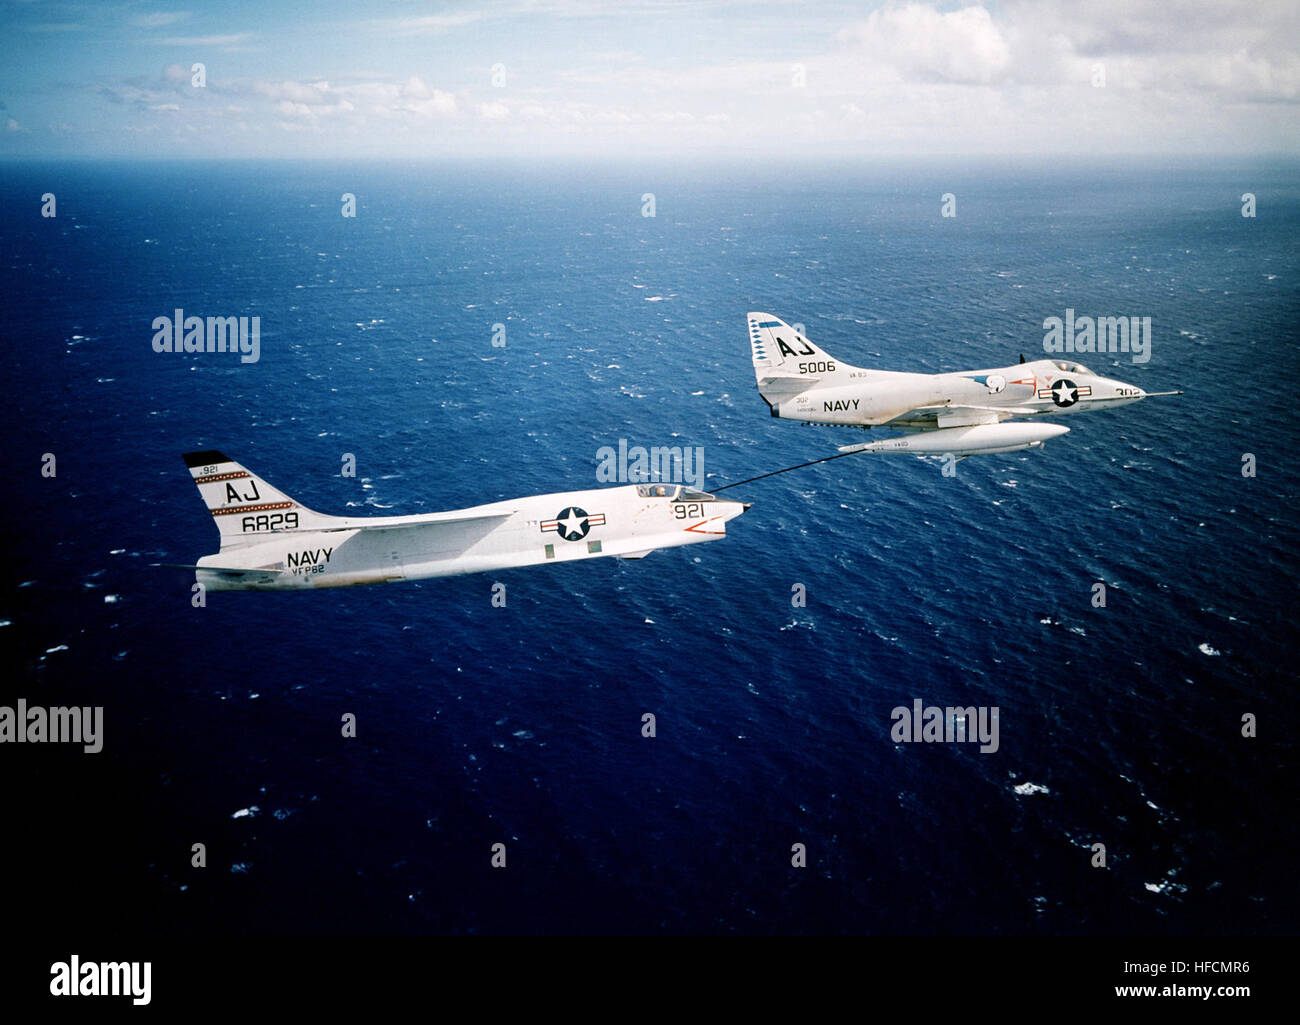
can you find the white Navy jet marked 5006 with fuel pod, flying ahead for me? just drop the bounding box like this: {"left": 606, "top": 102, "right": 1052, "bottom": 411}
{"left": 749, "top": 313, "right": 1182, "bottom": 457}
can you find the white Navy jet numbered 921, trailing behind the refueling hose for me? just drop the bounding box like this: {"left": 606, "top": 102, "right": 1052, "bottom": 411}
{"left": 181, "top": 451, "right": 749, "bottom": 591}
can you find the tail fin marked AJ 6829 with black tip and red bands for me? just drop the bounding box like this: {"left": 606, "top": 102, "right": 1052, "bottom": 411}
{"left": 185, "top": 450, "right": 341, "bottom": 548}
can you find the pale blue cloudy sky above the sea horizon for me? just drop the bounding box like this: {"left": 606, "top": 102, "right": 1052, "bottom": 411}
{"left": 0, "top": 0, "right": 1300, "bottom": 161}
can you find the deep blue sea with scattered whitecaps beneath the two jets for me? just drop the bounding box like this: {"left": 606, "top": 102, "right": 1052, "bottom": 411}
{"left": 0, "top": 155, "right": 1300, "bottom": 931}
